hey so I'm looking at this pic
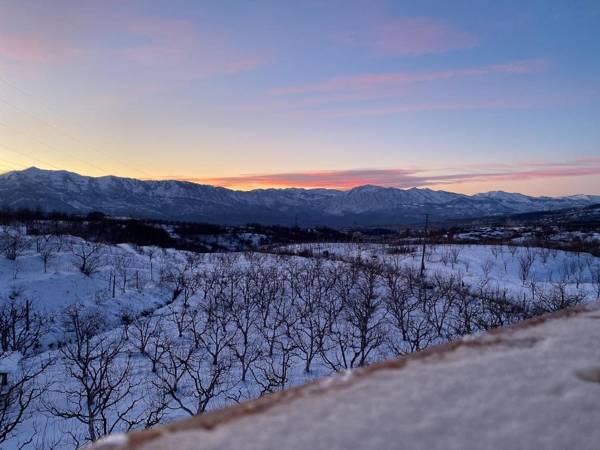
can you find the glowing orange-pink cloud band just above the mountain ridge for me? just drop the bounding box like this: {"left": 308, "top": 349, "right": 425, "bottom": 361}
{"left": 176, "top": 158, "right": 600, "bottom": 189}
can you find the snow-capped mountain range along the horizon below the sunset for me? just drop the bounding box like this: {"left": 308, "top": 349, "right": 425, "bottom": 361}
{"left": 0, "top": 167, "right": 600, "bottom": 226}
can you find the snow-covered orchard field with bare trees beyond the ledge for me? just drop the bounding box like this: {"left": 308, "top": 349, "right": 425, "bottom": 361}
{"left": 0, "top": 230, "right": 600, "bottom": 449}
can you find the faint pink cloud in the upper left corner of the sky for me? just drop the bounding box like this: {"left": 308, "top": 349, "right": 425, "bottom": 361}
{"left": 0, "top": 3, "right": 265, "bottom": 81}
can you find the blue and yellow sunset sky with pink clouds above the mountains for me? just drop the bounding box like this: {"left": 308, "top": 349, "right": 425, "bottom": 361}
{"left": 0, "top": 0, "right": 600, "bottom": 195}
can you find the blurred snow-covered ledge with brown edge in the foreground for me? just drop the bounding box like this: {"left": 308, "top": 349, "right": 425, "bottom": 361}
{"left": 89, "top": 304, "right": 600, "bottom": 450}
